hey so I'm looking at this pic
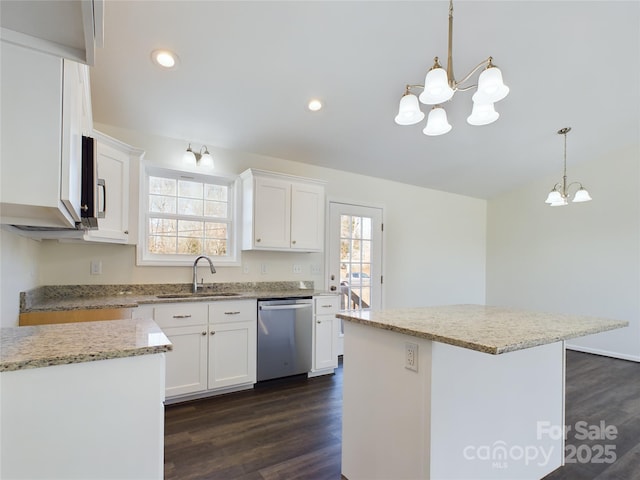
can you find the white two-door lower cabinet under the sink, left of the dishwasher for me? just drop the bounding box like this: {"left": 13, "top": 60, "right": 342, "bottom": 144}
{"left": 153, "top": 300, "right": 257, "bottom": 399}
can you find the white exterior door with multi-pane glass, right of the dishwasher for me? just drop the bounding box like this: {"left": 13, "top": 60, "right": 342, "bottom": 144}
{"left": 327, "top": 202, "right": 382, "bottom": 355}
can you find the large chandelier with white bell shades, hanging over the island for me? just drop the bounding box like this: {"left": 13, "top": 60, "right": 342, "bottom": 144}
{"left": 395, "top": 0, "right": 509, "bottom": 136}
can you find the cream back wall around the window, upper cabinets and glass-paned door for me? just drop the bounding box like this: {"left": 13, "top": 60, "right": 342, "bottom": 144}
{"left": 2, "top": 124, "right": 486, "bottom": 324}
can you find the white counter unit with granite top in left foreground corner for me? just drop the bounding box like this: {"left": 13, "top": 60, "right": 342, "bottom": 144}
{"left": 0, "top": 319, "right": 171, "bottom": 480}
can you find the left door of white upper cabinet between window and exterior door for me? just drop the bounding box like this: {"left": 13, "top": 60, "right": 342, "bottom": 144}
{"left": 254, "top": 178, "right": 291, "bottom": 248}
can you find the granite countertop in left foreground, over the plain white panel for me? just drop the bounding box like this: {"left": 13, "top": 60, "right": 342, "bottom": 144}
{"left": 0, "top": 319, "right": 172, "bottom": 372}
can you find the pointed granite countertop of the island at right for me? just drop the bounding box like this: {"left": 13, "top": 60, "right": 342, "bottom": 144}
{"left": 337, "top": 305, "right": 629, "bottom": 355}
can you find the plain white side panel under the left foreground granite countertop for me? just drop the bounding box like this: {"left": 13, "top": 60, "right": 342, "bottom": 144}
{"left": 0, "top": 353, "right": 165, "bottom": 480}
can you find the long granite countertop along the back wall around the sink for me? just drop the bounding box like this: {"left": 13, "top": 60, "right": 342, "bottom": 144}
{"left": 20, "top": 282, "right": 335, "bottom": 313}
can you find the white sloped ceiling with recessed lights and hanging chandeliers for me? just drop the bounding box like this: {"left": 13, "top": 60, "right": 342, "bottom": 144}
{"left": 91, "top": 0, "right": 640, "bottom": 198}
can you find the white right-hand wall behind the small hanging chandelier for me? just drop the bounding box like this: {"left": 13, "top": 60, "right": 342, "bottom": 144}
{"left": 487, "top": 145, "right": 640, "bottom": 361}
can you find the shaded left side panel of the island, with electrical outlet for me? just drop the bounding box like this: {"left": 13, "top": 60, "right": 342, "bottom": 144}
{"left": 342, "top": 321, "right": 432, "bottom": 480}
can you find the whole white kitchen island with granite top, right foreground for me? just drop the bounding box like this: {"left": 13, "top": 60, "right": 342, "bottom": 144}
{"left": 338, "top": 305, "right": 628, "bottom": 480}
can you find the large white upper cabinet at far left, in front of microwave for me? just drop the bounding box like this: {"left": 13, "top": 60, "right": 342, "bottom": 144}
{"left": 0, "top": 41, "right": 91, "bottom": 228}
